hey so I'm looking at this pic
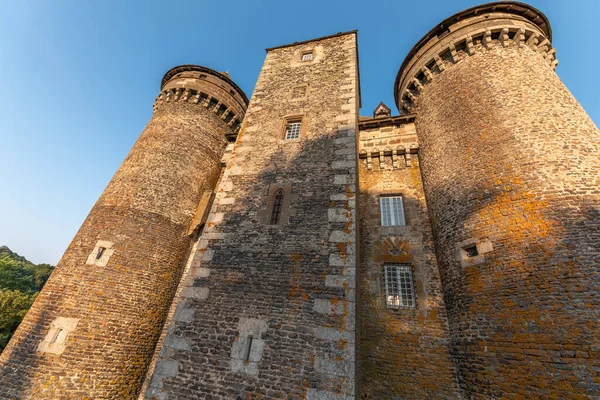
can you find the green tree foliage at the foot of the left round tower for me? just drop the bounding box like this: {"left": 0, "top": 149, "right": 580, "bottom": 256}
{"left": 0, "top": 246, "right": 54, "bottom": 352}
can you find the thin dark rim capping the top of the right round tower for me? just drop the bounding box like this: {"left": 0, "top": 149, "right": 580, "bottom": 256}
{"left": 393, "top": 1, "right": 552, "bottom": 109}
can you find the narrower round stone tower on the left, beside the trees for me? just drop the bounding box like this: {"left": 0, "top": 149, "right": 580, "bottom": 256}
{"left": 0, "top": 65, "right": 248, "bottom": 399}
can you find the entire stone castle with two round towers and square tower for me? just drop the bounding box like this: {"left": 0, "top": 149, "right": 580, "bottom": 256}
{"left": 0, "top": 1, "right": 600, "bottom": 400}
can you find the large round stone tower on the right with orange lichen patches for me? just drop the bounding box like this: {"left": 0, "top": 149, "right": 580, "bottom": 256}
{"left": 394, "top": 2, "right": 600, "bottom": 398}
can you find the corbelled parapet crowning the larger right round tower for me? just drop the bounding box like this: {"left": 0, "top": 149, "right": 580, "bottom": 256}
{"left": 394, "top": 2, "right": 558, "bottom": 113}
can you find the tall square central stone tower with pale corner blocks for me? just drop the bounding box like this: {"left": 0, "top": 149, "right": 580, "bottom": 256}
{"left": 146, "top": 32, "right": 359, "bottom": 399}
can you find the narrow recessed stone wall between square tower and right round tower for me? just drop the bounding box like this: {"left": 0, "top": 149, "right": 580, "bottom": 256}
{"left": 357, "top": 116, "right": 458, "bottom": 399}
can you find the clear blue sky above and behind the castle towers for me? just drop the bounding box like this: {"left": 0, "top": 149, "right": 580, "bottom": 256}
{"left": 0, "top": 0, "right": 600, "bottom": 264}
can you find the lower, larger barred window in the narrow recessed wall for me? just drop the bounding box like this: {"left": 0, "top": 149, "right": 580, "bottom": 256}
{"left": 385, "top": 264, "right": 415, "bottom": 308}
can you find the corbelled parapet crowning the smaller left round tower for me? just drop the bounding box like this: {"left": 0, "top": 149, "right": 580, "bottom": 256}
{"left": 154, "top": 65, "right": 248, "bottom": 139}
